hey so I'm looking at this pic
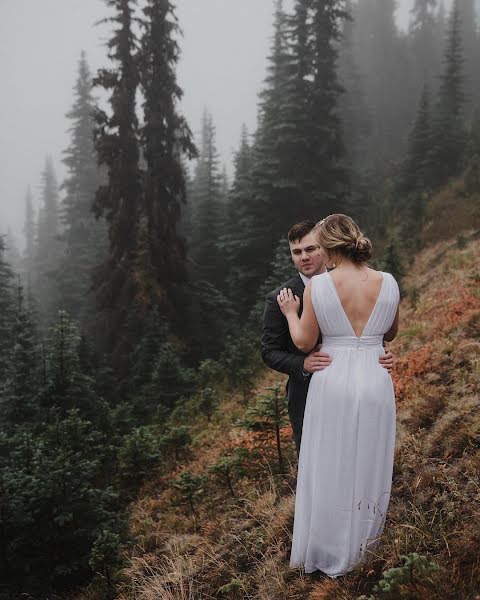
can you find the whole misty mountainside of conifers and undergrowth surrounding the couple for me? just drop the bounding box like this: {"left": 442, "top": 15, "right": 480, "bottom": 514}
{"left": 0, "top": 0, "right": 480, "bottom": 600}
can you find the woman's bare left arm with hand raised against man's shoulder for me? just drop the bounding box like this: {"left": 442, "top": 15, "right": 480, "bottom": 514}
{"left": 277, "top": 282, "right": 320, "bottom": 353}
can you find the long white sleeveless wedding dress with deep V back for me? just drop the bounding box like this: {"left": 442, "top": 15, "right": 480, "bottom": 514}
{"left": 290, "top": 273, "right": 400, "bottom": 577}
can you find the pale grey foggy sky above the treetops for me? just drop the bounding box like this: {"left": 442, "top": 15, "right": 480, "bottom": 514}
{"left": 0, "top": 0, "right": 442, "bottom": 244}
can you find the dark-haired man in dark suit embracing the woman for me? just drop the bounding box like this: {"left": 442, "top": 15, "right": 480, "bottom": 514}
{"left": 262, "top": 221, "right": 393, "bottom": 454}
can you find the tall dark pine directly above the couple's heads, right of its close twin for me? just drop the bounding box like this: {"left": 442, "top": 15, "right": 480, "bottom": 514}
{"left": 284, "top": 0, "right": 348, "bottom": 210}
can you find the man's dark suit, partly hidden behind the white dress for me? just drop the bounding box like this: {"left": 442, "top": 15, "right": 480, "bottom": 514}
{"left": 262, "top": 275, "right": 310, "bottom": 452}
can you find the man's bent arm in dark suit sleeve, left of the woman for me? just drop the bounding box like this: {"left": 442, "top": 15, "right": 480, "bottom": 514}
{"left": 262, "top": 292, "right": 305, "bottom": 381}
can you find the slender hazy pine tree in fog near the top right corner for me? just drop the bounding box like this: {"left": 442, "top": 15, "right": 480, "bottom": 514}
{"left": 434, "top": 0, "right": 465, "bottom": 184}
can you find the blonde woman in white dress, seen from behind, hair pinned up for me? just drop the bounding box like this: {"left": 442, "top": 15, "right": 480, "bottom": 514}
{"left": 277, "top": 214, "right": 400, "bottom": 577}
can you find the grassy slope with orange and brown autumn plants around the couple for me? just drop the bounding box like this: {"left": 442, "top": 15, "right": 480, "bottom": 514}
{"left": 75, "top": 235, "right": 480, "bottom": 600}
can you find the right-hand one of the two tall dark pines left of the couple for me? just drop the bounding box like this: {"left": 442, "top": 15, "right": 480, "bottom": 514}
{"left": 140, "top": 0, "right": 196, "bottom": 298}
